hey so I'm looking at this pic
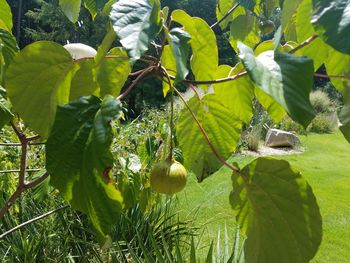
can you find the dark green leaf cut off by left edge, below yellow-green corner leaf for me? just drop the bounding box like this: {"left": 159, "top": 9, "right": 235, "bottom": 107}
{"left": 0, "top": 28, "right": 19, "bottom": 66}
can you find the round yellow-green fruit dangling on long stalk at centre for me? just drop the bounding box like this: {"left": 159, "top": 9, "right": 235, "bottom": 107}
{"left": 151, "top": 160, "right": 187, "bottom": 195}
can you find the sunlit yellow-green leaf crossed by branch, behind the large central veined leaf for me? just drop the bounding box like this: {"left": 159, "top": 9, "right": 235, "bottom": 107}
{"left": 214, "top": 64, "right": 254, "bottom": 123}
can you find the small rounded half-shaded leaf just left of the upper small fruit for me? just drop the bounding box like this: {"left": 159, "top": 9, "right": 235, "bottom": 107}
{"left": 230, "top": 13, "right": 260, "bottom": 53}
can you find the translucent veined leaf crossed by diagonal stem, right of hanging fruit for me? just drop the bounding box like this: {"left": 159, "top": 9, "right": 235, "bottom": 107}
{"left": 176, "top": 94, "right": 242, "bottom": 181}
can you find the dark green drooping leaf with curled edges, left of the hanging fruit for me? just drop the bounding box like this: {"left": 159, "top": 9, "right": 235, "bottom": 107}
{"left": 46, "top": 96, "right": 123, "bottom": 238}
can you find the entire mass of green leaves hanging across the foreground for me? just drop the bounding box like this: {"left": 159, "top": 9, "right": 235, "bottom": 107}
{"left": 0, "top": 0, "right": 350, "bottom": 262}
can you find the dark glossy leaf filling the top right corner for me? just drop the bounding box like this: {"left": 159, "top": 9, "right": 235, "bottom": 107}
{"left": 312, "top": 0, "right": 350, "bottom": 54}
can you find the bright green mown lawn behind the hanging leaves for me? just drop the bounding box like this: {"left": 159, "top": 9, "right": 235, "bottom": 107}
{"left": 177, "top": 133, "right": 350, "bottom": 263}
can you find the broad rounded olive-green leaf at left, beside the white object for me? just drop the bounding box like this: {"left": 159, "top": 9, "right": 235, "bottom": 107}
{"left": 5, "top": 41, "right": 79, "bottom": 138}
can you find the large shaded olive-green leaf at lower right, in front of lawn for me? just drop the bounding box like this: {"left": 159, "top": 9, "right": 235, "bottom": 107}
{"left": 230, "top": 158, "right": 322, "bottom": 263}
